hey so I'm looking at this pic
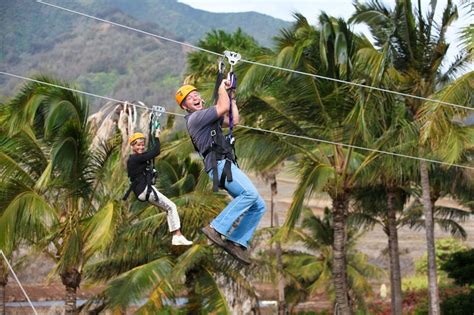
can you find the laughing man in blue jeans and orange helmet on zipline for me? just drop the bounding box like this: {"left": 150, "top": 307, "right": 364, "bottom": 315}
{"left": 176, "top": 80, "right": 265, "bottom": 264}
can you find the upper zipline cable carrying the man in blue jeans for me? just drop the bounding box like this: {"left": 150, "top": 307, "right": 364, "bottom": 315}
{"left": 36, "top": 0, "right": 474, "bottom": 110}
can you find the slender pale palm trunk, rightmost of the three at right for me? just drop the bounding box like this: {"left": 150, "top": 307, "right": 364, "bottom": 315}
{"left": 420, "top": 161, "right": 441, "bottom": 315}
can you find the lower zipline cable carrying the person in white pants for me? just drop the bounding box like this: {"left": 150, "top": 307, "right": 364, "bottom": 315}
{"left": 0, "top": 71, "right": 474, "bottom": 170}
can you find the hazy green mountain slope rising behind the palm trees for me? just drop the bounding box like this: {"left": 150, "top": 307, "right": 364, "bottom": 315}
{"left": 0, "top": 0, "right": 288, "bottom": 108}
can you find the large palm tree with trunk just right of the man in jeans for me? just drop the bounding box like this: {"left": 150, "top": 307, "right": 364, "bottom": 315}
{"left": 234, "top": 14, "right": 396, "bottom": 314}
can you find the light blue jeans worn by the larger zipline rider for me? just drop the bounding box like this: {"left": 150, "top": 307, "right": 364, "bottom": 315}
{"left": 208, "top": 160, "right": 265, "bottom": 248}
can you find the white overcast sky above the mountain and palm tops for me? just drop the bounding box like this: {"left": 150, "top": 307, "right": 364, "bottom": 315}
{"left": 178, "top": 0, "right": 474, "bottom": 68}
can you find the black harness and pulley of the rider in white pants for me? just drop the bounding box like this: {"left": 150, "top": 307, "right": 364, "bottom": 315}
{"left": 122, "top": 102, "right": 166, "bottom": 201}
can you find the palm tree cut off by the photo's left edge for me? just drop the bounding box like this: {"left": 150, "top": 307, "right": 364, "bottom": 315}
{"left": 0, "top": 105, "right": 58, "bottom": 314}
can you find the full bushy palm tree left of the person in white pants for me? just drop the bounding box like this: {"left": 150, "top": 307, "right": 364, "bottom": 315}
{"left": 2, "top": 77, "right": 122, "bottom": 314}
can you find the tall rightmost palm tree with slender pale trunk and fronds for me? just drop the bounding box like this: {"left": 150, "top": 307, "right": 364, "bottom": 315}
{"left": 352, "top": 0, "right": 473, "bottom": 314}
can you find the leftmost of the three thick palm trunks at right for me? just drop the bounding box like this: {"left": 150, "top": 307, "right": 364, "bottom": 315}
{"left": 333, "top": 193, "right": 352, "bottom": 315}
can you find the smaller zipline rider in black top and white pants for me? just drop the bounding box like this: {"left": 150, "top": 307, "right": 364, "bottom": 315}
{"left": 123, "top": 129, "right": 193, "bottom": 245}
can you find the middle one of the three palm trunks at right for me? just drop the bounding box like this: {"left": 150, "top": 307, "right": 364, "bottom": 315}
{"left": 387, "top": 190, "right": 403, "bottom": 315}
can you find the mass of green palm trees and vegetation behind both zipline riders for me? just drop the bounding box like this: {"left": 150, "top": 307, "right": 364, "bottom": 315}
{"left": 0, "top": 0, "right": 474, "bottom": 314}
